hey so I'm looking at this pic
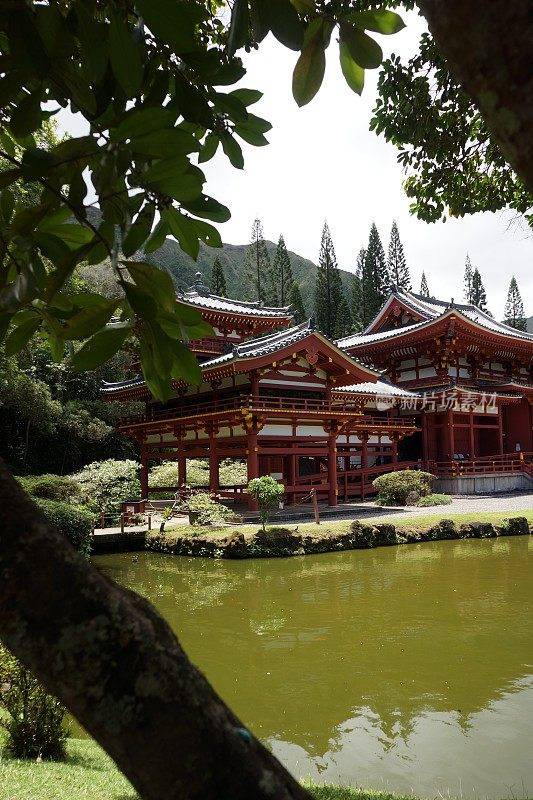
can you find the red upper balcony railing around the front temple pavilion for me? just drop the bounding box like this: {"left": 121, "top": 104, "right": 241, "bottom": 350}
{"left": 121, "top": 395, "right": 416, "bottom": 428}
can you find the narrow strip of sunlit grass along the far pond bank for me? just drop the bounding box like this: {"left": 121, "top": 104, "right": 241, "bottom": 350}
{"left": 161, "top": 506, "right": 533, "bottom": 538}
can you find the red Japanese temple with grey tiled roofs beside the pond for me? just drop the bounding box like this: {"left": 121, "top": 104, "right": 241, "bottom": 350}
{"left": 103, "top": 273, "right": 533, "bottom": 509}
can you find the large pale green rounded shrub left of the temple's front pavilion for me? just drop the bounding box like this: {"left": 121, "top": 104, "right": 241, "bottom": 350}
{"left": 70, "top": 458, "right": 141, "bottom": 512}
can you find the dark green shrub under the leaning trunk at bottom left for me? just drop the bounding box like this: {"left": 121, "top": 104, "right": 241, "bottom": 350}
{"left": 0, "top": 643, "right": 68, "bottom": 761}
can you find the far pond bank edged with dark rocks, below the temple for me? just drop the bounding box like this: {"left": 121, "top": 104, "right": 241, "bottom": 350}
{"left": 146, "top": 517, "right": 533, "bottom": 559}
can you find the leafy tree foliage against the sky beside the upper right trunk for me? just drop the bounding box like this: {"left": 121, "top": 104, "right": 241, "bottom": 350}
{"left": 370, "top": 33, "right": 533, "bottom": 225}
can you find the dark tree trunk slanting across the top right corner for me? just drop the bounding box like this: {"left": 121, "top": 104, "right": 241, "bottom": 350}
{"left": 417, "top": 0, "right": 533, "bottom": 192}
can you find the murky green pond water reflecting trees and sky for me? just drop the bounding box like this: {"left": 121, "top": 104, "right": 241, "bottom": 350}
{"left": 95, "top": 537, "right": 533, "bottom": 799}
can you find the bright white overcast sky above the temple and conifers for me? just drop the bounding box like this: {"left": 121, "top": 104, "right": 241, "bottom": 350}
{"left": 62, "top": 13, "right": 533, "bottom": 317}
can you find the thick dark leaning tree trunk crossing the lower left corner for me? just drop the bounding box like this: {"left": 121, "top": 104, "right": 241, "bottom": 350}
{"left": 0, "top": 459, "right": 309, "bottom": 800}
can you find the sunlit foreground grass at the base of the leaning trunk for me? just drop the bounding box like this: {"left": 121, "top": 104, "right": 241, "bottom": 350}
{"left": 0, "top": 739, "right": 413, "bottom": 800}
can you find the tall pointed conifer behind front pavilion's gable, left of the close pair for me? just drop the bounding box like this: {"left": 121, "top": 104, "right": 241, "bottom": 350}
{"left": 315, "top": 222, "right": 349, "bottom": 339}
